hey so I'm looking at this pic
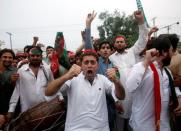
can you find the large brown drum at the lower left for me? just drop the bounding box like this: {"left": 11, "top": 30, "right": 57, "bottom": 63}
{"left": 6, "top": 97, "right": 66, "bottom": 131}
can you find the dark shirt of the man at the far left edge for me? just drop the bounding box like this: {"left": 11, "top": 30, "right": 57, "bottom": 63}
{"left": 0, "top": 67, "right": 17, "bottom": 114}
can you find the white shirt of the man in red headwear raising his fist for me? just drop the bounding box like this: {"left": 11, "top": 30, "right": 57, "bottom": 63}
{"left": 109, "top": 24, "right": 148, "bottom": 118}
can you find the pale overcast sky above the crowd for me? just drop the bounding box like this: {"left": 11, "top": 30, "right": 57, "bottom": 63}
{"left": 0, "top": 0, "right": 181, "bottom": 51}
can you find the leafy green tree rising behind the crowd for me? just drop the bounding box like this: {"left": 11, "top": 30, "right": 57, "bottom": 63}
{"left": 98, "top": 10, "right": 138, "bottom": 47}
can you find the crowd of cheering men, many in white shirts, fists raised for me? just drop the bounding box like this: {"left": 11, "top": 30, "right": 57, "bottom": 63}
{"left": 0, "top": 11, "right": 181, "bottom": 131}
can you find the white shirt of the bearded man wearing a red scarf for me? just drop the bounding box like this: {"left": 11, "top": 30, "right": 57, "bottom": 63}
{"left": 126, "top": 62, "right": 180, "bottom": 131}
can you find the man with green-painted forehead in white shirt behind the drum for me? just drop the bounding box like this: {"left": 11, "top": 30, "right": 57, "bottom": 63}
{"left": 8, "top": 46, "right": 53, "bottom": 118}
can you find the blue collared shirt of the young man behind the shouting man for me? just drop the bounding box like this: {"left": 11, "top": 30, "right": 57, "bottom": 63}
{"left": 97, "top": 57, "right": 114, "bottom": 76}
